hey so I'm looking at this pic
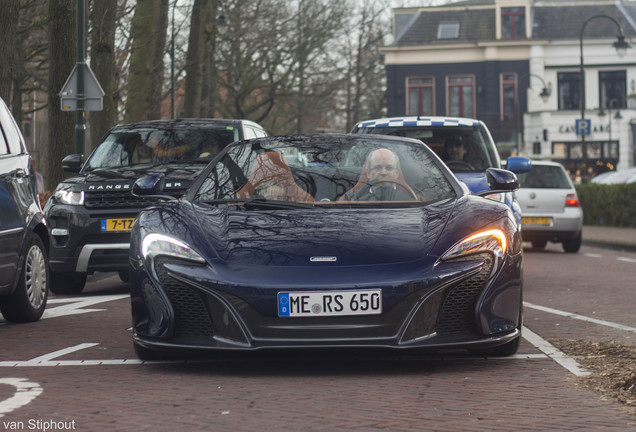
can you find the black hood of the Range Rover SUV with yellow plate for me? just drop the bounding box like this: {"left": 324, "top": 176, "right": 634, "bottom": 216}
{"left": 59, "top": 163, "right": 205, "bottom": 189}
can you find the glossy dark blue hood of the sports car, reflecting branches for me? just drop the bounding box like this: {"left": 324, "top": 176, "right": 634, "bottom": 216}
{"left": 186, "top": 203, "right": 452, "bottom": 268}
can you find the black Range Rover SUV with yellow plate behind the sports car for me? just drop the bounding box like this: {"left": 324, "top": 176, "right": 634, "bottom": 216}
{"left": 44, "top": 119, "right": 267, "bottom": 294}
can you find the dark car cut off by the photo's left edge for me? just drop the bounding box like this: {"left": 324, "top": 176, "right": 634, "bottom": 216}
{"left": 0, "top": 98, "right": 49, "bottom": 322}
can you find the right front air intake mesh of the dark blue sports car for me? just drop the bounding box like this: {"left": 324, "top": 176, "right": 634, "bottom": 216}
{"left": 436, "top": 254, "right": 494, "bottom": 333}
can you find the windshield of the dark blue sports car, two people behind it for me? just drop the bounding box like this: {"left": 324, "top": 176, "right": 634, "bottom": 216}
{"left": 194, "top": 134, "right": 456, "bottom": 205}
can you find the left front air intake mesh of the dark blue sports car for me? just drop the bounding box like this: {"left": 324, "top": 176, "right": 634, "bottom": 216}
{"left": 155, "top": 258, "right": 214, "bottom": 337}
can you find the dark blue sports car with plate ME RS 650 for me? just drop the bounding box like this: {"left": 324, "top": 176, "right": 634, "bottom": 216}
{"left": 130, "top": 134, "right": 523, "bottom": 359}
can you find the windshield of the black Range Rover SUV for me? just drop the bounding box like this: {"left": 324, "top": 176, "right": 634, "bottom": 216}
{"left": 85, "top": 124, "right": 240, "bottom": 170}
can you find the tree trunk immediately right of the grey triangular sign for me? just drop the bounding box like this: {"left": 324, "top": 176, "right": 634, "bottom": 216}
{"left": 86, "top": 0, "right": 118, "bottom": 154}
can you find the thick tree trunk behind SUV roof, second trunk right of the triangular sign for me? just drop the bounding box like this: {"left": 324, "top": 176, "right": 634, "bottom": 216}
{"left": 124, "top": 0, "right": 168, "bottom": 123}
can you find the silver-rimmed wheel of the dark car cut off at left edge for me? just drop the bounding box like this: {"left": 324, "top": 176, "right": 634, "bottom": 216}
{"left": 0, "top": 234, "right": 49, "bottom": 322}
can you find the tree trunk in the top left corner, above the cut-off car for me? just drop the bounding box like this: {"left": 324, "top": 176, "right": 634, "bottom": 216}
{"left": 0, "top": 0, "right": 20, "bottom": 106}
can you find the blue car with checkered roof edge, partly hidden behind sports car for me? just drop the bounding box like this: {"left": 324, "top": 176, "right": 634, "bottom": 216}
{"left": 351, "top": 117, "right": 531, "bottom": 222}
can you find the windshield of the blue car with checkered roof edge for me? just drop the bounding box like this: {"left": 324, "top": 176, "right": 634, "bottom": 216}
{"left": 356, "top": 125, "right": 500, "bottom": 172}
